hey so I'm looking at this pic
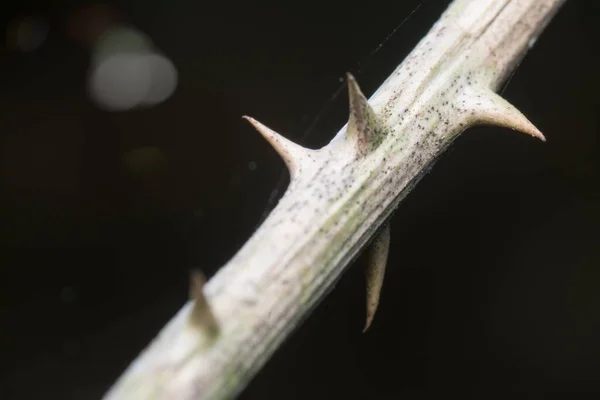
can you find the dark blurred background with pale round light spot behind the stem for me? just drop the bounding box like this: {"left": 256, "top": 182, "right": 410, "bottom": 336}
{"left": 0, "top": 0, "right": 600, "bottom": 400}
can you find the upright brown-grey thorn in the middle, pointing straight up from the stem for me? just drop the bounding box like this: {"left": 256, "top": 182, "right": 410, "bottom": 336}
{"left": 346, "top": 73, "right": 383, "bottom": 155}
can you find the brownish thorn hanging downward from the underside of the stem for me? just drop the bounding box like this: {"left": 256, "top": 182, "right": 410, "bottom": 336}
{"left": 363, "top": 223, "right": 390, "bottom": 333}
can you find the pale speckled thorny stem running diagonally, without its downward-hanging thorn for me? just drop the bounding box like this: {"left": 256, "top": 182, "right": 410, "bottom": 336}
{"left": 105, "top": 0, "right": 564, "bottom": 400}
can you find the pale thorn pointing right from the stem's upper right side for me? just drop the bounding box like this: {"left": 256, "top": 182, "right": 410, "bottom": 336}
{"left": 465, "top": 90, "right": 546, "bottom": 142}
